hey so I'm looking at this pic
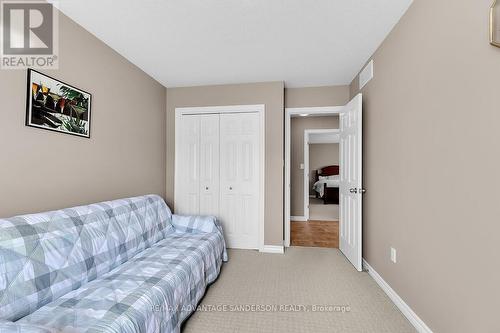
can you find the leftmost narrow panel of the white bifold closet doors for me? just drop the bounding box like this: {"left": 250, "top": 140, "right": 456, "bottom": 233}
{"left": 175, "top": 115, "right": 200, "bottom": 215}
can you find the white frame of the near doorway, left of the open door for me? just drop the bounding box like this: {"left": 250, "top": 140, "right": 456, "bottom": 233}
{"left": 284, "top": 106, "right": 343, "bottom": 247}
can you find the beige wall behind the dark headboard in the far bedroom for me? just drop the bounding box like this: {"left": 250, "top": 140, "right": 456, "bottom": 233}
{"left": 309, "top": 143, "right": 339, "bottom": 194}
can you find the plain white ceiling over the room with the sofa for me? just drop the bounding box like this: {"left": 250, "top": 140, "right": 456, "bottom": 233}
{"left": 50, "top": 0, "right": 412, "bottom": 87}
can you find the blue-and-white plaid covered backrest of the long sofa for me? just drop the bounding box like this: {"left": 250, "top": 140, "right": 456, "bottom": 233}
{"left": 0, "top": 195, "right": 172, "bottom": 321}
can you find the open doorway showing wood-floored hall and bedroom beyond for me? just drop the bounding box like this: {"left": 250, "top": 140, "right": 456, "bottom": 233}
{"left": 290, "top": 113, "right": 339, "bottom": 248}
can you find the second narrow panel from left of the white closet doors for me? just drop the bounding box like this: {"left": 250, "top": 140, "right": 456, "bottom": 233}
{"left": 199, "top": 114, "right": 220, "bottom": 216}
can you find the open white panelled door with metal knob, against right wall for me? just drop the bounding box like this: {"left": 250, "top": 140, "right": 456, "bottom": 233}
{"left": 339, "top": 94, "right": 364, "bottom": 271}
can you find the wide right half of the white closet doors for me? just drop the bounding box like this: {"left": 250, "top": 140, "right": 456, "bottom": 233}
{"left": 219, "top": 113, "right": 260, "bottom": 249}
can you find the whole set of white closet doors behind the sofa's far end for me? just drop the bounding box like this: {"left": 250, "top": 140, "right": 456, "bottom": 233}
{"left": 175, "top": 113, "right": 260, "bottom": 249}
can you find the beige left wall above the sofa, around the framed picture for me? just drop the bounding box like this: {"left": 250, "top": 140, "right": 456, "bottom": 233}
{"left": 0, "top": 14, "right": 166, "bottom": 217}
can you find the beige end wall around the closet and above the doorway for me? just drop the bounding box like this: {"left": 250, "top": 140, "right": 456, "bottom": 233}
{"left": 166, "top": 82, "right": 349, "bottom": 241}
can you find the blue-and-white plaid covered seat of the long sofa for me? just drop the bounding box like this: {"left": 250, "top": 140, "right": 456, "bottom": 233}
{"left": 19, "top": 231, "right": 225, "bottom": 333}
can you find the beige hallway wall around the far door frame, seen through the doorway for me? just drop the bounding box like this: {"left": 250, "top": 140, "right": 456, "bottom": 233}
{"left": 290, "top": 116, "right": 339, "bottom": 216}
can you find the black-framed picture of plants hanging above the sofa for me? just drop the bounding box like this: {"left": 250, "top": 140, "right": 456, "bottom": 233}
{"left": 26, "top": 69, "right": 92, "bottom": 138}
